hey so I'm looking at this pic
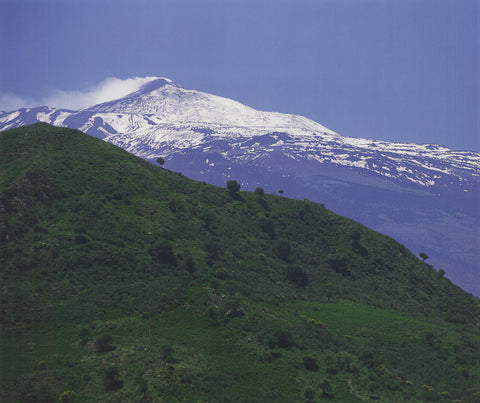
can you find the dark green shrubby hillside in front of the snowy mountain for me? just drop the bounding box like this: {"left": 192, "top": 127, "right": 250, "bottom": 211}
{"left": 0, "top": 124, "right": 480, "bottom": 402}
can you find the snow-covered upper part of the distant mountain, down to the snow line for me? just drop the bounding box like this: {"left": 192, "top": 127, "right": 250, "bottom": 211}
{"left": 0, "top": 78, "right": 480, "bottom": 192}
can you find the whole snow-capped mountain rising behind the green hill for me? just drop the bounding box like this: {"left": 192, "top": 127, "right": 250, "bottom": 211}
{"left": 0, "top": 78, "right": 480, "bottom": 294}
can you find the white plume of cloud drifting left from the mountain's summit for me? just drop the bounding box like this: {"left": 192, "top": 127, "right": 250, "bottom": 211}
{"left": 0, "top": 77, "right": 158, "bottom": 111}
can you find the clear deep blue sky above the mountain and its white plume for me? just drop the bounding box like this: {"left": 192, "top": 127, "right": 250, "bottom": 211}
{"left": 0, "top": 0, "right": 480, "bottom": 151}
